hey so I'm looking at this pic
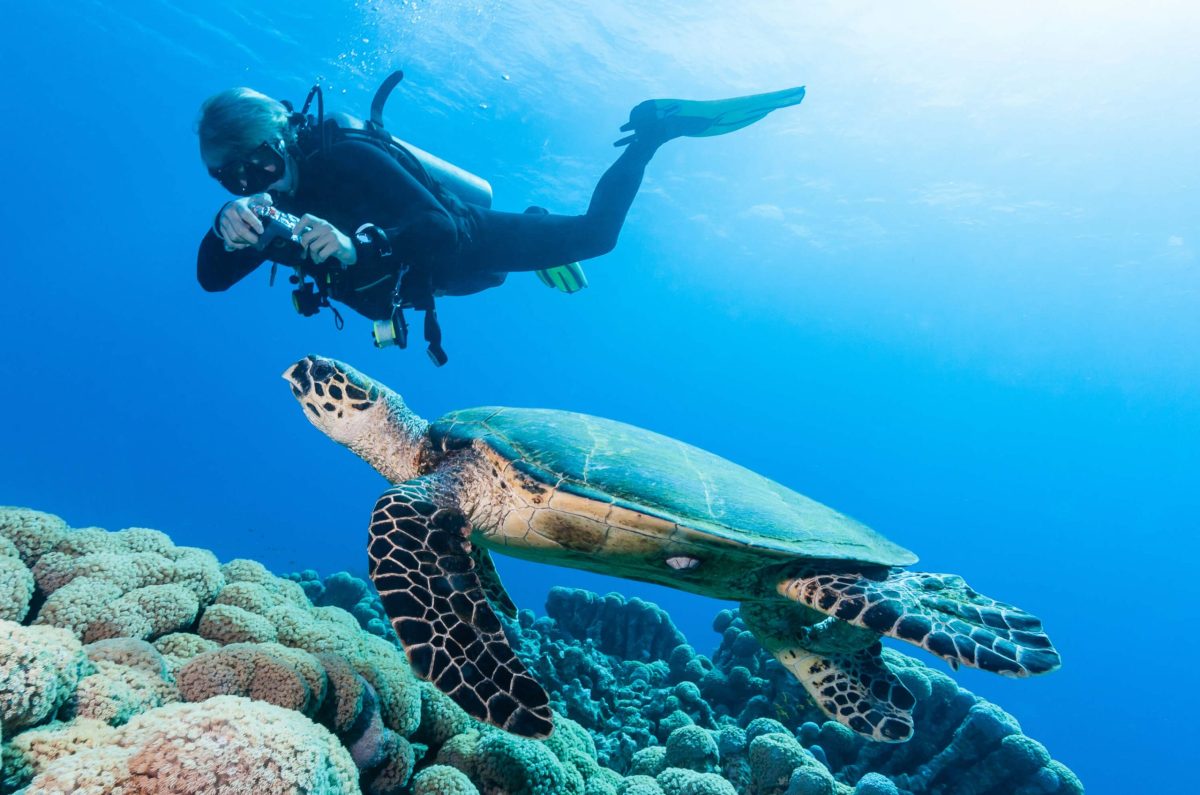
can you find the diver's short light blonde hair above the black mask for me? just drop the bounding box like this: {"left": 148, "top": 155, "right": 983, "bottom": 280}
{"left": 196, "top": 88, "right": 295, "bottom": 168}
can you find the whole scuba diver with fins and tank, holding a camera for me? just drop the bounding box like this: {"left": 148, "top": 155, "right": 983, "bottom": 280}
{"left": 197, "top": 72, "right": 804, "bottom": 365}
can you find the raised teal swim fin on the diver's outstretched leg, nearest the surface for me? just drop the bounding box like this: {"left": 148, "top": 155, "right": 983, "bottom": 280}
{"left": 613, "top": 85, "right": 804, "bottom": 147}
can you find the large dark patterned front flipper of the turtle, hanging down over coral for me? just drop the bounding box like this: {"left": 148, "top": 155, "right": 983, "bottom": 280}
{"left": 370, "top": 476, "right": 554, "bottom": 737}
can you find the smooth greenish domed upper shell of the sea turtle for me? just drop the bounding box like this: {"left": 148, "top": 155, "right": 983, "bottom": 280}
{"left": 430, "top": 407, "right": 917, "bottom": 566}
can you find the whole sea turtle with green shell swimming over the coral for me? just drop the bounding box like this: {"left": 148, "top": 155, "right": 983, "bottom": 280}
{"left": 283, "top": 357, "right": 1060, "bottom": 742}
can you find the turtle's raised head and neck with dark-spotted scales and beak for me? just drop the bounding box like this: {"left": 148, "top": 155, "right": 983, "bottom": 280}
{"left": 283, "top": 355, "right": 428, "bottom": 483}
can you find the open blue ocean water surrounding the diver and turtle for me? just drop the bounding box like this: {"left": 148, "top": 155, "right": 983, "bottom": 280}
{"left": 0, "top": 0, "right": 1200, "bottom": 793}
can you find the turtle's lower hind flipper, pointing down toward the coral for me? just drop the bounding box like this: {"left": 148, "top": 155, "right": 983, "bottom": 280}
{"left": 740, "top": 602, "right": 917, "bottom": 742}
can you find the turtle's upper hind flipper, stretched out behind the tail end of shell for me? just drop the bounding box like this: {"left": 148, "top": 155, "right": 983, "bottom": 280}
{"left": 778, "top": 570, "right": 1061, "bottom": 676}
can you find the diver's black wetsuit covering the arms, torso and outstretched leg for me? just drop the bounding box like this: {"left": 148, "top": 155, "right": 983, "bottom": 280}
{"left": 197, "top": 141, "right": 655, "bottom": 319}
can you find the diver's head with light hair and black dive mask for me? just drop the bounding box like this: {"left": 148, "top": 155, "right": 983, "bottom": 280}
{"left": 196, "top": 88, "right": 296, "bottom": 196}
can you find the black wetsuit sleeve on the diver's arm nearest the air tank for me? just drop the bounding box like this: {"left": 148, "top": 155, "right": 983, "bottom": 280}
{"left": 331, "top": 142, "right": 458, "bottom": 277}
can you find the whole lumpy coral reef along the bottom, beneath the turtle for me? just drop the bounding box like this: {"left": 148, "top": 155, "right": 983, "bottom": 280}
{"left": 0, "top": 508, "right": 1082, "bottom": 795}
